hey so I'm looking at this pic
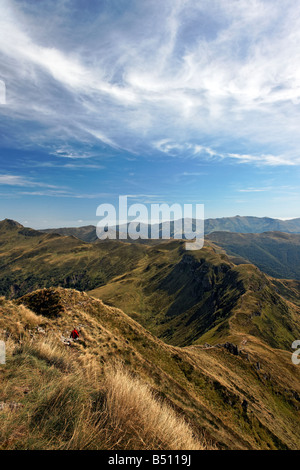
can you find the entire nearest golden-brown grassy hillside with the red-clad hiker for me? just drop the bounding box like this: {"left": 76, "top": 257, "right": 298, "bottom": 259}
{"left": 0, "top": 288, "right": 300, "bottom": 449}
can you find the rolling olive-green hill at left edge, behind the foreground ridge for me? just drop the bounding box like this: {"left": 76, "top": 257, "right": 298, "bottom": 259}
{"left": 0, "top": 220, "right": 146, "bottom": 297}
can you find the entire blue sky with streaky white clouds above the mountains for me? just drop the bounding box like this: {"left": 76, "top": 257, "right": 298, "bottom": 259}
{"left": 0, "top": 0, "right": 300, "bottom": 228}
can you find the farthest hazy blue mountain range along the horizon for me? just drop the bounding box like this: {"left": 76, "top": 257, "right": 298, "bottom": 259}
{"left": 41, "top": 215, "right": 300, "bottom": 242}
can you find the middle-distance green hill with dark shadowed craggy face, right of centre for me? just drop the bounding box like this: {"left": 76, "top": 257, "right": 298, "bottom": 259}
{"left": 91, "top": 242, "right": 300, "bottom": 349}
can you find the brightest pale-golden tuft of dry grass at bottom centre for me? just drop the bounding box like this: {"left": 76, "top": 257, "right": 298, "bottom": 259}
{"left": 105, "top": 366, "right": 205, "bottom": 450}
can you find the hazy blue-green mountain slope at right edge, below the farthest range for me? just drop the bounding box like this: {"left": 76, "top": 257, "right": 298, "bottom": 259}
{"left": 207, "top": 232, "right": 300, "bottom": 280}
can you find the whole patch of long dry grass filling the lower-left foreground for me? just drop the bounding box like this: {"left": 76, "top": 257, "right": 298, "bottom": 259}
{"left": 0, "top": 337, "right": 205, "bottom": 450}
